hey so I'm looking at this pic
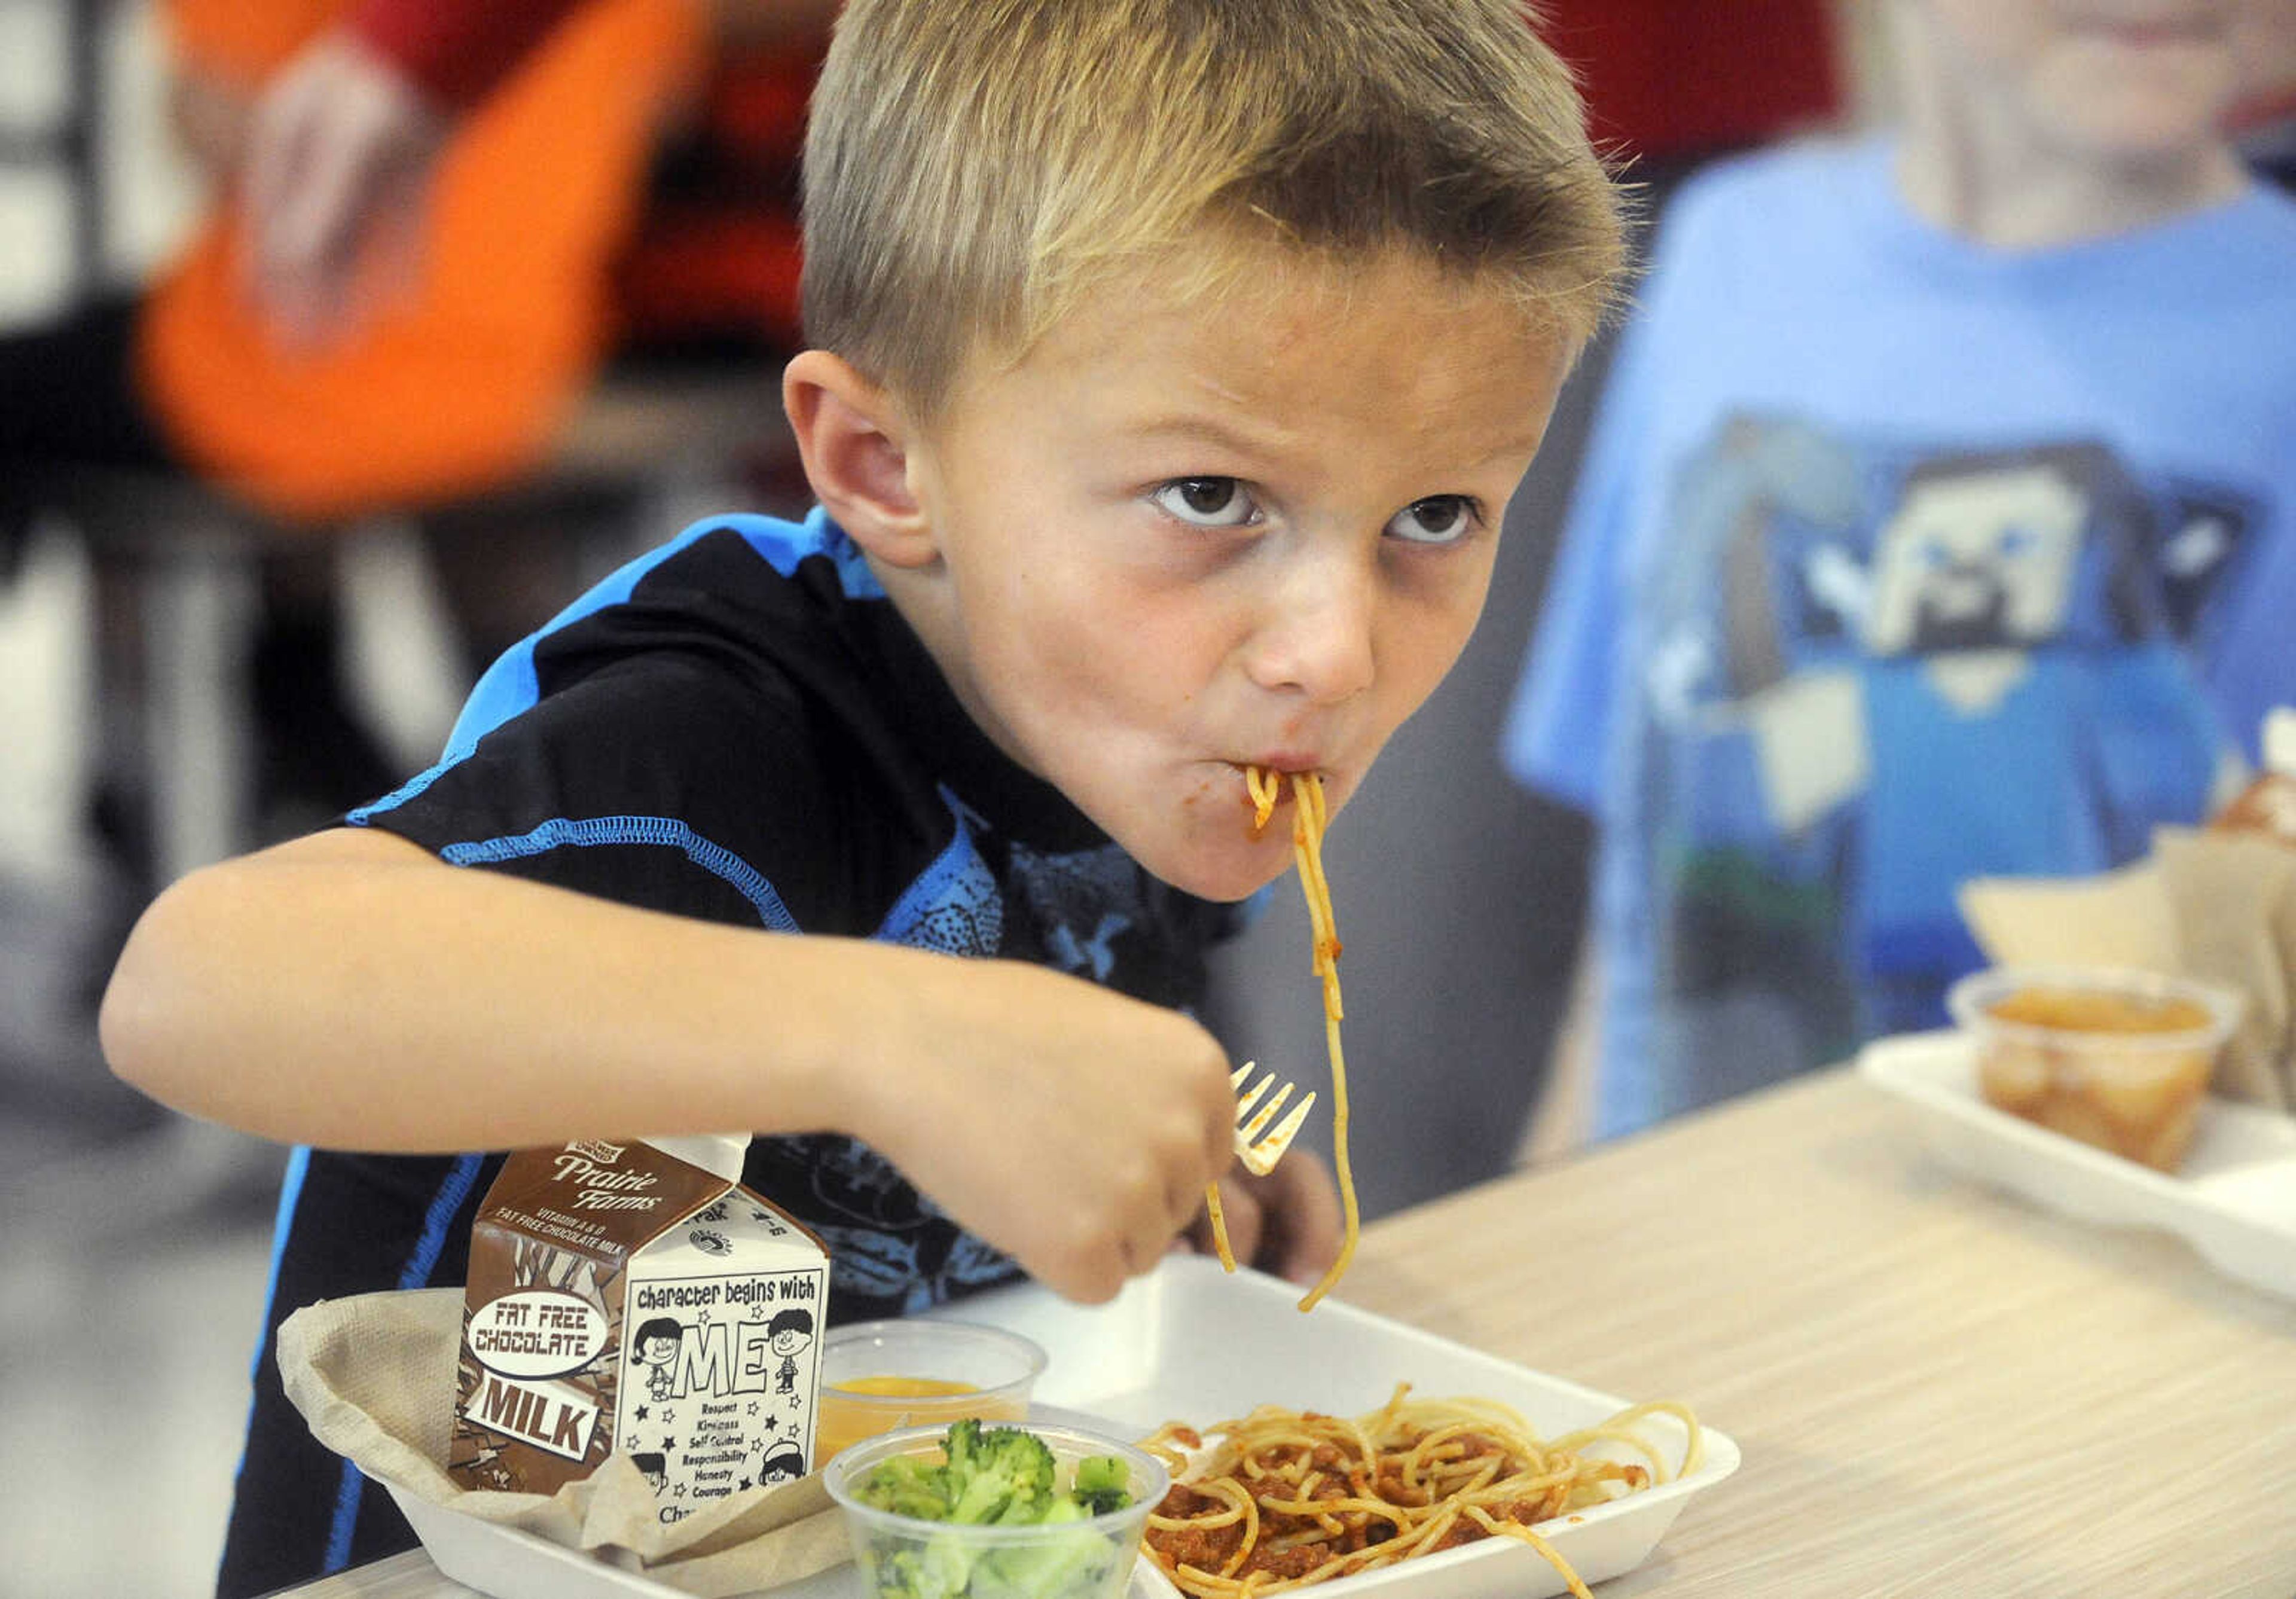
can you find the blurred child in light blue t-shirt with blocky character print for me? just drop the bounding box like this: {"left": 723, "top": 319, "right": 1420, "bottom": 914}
{"left": 1504, "top": 0, "right": 2296, "bottom": 1137}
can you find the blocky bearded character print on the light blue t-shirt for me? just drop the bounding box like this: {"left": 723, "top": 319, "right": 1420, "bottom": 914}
{"left": 1635, "top": 414, "right": 2243, "bottom": 1048}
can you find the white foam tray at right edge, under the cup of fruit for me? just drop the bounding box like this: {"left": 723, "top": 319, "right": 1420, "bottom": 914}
{"left": 1858, "top": 1029, "right": 2296, "bottom": 1298}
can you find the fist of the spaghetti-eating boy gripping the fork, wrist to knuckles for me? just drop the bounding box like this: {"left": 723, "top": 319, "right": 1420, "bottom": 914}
{"left": 854, "top": 960, "right": 1235, "bottom": 1305}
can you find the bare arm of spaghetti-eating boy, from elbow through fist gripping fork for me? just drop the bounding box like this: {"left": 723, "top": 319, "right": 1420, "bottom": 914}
{"left": 103, "top": 829, "right": 1235, "bottom": 1302}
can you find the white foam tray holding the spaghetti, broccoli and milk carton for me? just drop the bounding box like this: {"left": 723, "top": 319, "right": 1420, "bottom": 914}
{"left": 386, "top": 1255, "right": 1738, "bottom": 1599}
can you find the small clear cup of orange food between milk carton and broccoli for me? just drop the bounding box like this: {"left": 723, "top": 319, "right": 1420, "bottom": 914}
{"left": 813, "top": 1316, "right": 1045, "bottom": 1466}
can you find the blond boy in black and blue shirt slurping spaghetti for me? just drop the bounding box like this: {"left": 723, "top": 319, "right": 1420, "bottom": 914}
{"left": 103, "top": 0, "right": 1621, "bottom": 1592}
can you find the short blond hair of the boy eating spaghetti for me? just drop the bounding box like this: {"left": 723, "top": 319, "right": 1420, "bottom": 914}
{"left": 804, "top": 0, "right": 1626, "bottom": 414}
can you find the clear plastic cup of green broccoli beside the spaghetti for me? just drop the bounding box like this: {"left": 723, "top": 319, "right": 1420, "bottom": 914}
{"left": 822, "top": 1420, "right": 1171, "bottom": 1599}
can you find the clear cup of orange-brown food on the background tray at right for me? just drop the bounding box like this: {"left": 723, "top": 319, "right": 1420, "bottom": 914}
{"left": 1947, "top": 965, "right": 2243, "bottom": 1171}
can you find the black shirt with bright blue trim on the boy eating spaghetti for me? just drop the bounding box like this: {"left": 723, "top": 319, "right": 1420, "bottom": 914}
{"left": 221, "top": 512, "right": 1235, "bottom": 1594}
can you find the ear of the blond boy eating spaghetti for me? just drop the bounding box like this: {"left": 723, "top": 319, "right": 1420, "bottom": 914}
{"left": 781, "top": 349, "right": 939, "bottom": 567}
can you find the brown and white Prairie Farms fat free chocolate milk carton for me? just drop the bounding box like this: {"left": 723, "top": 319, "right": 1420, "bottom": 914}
{"left": 448, "top": 1137, "right": 829, "bottom": 1523}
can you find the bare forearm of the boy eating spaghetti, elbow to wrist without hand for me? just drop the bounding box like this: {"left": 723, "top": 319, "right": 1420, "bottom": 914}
{"left": 101, "top": 832, "right": 937, "bottom": 1151}
